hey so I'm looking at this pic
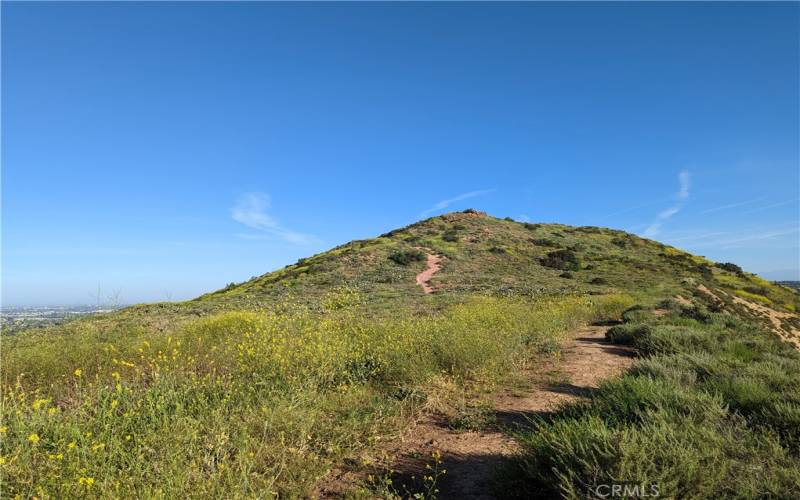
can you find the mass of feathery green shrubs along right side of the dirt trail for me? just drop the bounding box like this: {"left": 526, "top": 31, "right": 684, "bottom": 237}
{"left": 516, "top": 302, "right": 800, "bottom": 498}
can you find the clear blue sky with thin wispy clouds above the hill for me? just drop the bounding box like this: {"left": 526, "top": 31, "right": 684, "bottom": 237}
{"left": 2, "top": 2, "right": 800, "bottom": 305}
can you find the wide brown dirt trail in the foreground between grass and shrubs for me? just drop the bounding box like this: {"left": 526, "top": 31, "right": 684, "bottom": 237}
{"left": 389, "top": 326, "right": 633, "bottom": 499}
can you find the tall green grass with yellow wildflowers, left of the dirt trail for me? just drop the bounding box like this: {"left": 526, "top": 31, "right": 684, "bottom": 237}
{"left": 0, "top": 292, "right": 631, "bottom": 497}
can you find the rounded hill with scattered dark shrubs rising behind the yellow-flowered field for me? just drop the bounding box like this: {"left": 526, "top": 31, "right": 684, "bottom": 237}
{"left": 116, "top": 210, "right": 800, "bottom": 336}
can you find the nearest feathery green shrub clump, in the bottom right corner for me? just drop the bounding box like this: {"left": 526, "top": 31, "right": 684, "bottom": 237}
{"left": 518, "top": 410, "right": 800, "bottom": 498}
